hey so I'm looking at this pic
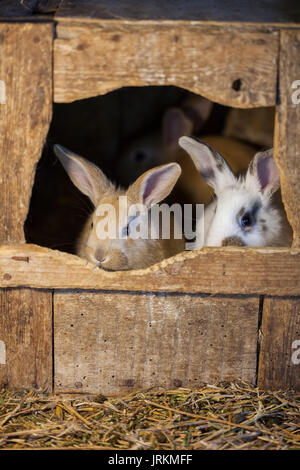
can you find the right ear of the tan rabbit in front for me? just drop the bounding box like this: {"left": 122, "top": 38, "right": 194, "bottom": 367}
{"left": 127, "top": 163, "right": 181, "bottom": 207}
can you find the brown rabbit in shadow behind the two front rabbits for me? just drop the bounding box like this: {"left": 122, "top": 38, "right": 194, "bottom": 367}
{"left": 117, "top": 96, "right": 255, "bottom": 204}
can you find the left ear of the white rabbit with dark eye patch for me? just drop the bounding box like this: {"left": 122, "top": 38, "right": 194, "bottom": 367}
{"left": 179, "top": 136, "right": 236, "bottom": 195}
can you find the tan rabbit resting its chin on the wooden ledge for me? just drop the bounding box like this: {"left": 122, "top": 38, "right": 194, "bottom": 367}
{"left": 54, "top": 145, "right": 184, "bottom": 271}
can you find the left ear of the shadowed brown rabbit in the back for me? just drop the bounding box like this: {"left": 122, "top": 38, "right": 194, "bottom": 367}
{"left": 162, "top": 108, "right": 193, "bottom": 147}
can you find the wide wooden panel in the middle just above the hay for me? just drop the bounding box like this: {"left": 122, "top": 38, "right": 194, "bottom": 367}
{"left": 54, "top": 292, "right": 259, "bottom": 395}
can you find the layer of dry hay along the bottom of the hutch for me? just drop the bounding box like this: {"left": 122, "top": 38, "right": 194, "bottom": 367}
{"left": 0, "top": 383, "right": 300, "bottom": 450}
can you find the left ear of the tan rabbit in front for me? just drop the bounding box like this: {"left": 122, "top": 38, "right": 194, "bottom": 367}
{"left": 54, "top": 145, "right": 110, "bottom": 205}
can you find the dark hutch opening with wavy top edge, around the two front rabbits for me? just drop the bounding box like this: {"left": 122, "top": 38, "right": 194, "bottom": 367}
{"left": 25, "top": 86, "right": 286, "bottom": 276}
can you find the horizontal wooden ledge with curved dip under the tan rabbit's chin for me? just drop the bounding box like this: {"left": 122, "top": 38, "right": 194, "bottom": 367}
{"left": 0, "top": 245, "right": 300, "bottom": 295}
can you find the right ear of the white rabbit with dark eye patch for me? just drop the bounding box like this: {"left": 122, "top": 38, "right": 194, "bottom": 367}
{"left": 246, "top": 149, "right": 280, "bottom": 196}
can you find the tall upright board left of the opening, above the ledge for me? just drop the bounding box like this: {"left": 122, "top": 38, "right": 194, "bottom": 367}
{"left": 0, "top": 23, "right": 53, "bottom": 242}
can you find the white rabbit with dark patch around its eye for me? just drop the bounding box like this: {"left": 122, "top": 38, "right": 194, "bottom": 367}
{"left": 179, "top": 136, "right": 292, "bottom": 248}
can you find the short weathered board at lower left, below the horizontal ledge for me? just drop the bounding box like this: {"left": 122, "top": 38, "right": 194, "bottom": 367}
{"left": 0, "top": 289, "right": 52, "bottom": 391}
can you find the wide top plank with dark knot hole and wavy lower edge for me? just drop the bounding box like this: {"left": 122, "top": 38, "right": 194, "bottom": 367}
{"left": 54, "top": 20, "right": 278, "bottom": 108}
